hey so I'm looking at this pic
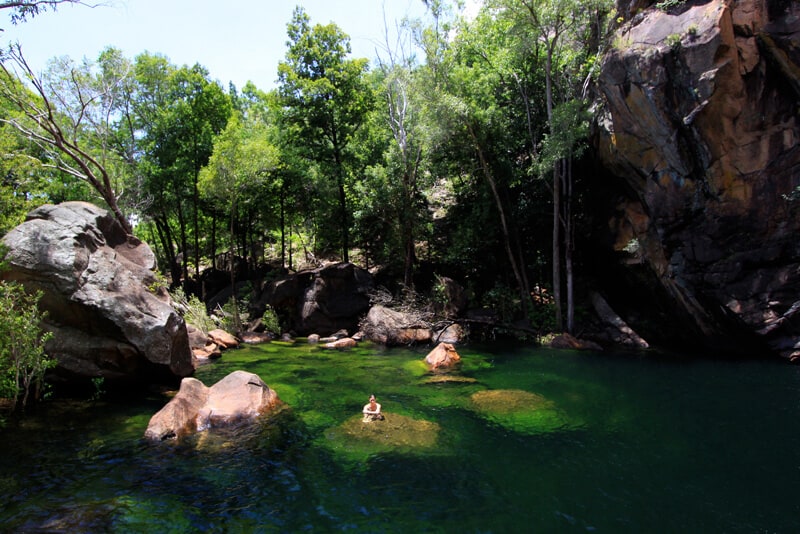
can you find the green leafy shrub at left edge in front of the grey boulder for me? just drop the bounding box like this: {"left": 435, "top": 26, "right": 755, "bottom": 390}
{"left": 0, "top": 282, "right": 57, "bottom": 409}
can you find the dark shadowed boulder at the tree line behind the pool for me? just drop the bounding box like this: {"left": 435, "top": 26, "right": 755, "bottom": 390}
{"left": 255, "top": 263, "right": 373, "bottom": 336}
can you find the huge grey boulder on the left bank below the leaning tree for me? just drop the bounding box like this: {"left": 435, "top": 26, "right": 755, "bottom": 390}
{"left": 0, "top": 202, "right": 194, "bottom": 381}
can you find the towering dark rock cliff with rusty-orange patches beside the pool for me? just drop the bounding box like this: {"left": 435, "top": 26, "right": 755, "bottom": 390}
{"left": 595, "top": 0, "right": 800, "bottom": 358}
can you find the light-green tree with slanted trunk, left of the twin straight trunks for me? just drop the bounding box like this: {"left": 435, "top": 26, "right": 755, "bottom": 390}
{"left": 417, "top": 2, "right": 530, "bottom": 316}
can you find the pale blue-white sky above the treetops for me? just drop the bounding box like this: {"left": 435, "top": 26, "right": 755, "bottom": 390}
{"left": 0, "top": 0, "right": 438, "bottom": 90}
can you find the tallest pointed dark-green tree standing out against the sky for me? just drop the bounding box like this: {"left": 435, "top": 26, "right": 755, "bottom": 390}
{"left": 278, "top": 7, "right": 373, "bottom": 261}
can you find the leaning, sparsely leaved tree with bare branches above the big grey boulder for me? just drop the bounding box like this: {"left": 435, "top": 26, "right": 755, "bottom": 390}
{"left": 0, "top": 45, "right": 132, "bottom": 233}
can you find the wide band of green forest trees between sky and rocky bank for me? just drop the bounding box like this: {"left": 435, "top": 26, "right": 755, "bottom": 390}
{"left": 0, "top": 0, "right": 624, "bottom": 342}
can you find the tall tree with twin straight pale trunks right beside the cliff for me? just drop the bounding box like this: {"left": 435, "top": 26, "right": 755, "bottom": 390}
{"left": 486, "top": 0, "right": 611, "bottom": 331}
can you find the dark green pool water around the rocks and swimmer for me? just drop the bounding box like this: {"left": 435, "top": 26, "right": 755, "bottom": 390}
{"left": 0, "top": 344, "right": 800, "bottom": 533}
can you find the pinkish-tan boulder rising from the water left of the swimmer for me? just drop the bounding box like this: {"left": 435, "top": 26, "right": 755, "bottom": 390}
{"left": 144, "top": 371, "right": 280, "bottom": 441}
